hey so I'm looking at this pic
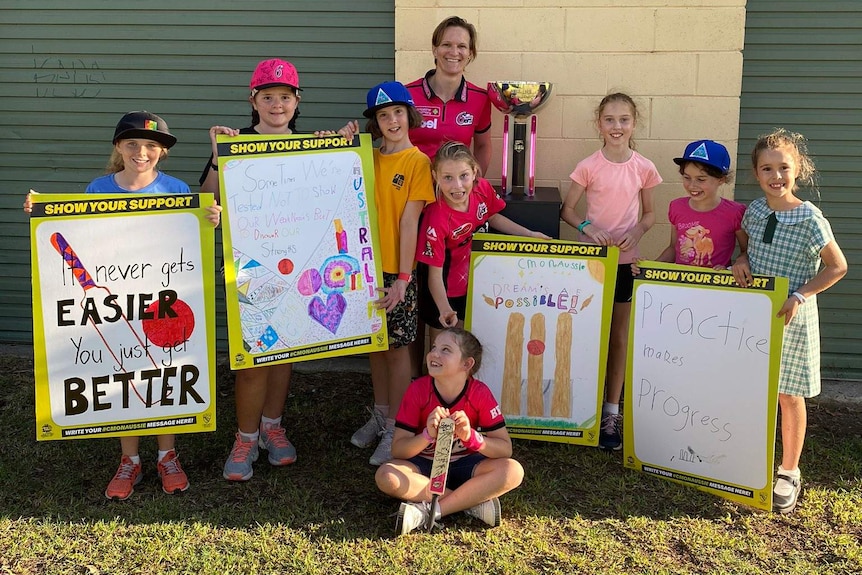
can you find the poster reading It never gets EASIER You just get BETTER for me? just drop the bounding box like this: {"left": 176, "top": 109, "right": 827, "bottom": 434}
{"left": 30, "top": 194, "right": 216, "bottom": 440}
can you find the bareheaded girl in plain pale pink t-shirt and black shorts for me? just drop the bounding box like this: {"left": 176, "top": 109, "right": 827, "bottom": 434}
{"left": 560, "top": 93, "right": 662, "bottom": 450}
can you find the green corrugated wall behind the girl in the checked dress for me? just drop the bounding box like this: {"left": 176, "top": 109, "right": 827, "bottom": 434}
{"left": 736, "top": 0, "right": 862, "bottom": 379}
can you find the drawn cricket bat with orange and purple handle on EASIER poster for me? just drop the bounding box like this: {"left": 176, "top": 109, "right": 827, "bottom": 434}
{"left": 51, "top": 232, "right": 159, "bottom": 405}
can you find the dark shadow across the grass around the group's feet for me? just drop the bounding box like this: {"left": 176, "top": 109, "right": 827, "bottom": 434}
{"left": 0, "top": 356, "right": 862, "bottom": 540}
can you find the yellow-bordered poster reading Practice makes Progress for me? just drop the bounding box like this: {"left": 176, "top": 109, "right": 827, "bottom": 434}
{"left": 623, "top": 262, "right": 787, "bottom": 509}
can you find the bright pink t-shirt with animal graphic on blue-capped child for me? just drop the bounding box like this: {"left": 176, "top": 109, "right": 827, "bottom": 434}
{"left": 667, "top": 198, "right": 745, "bottom": 268}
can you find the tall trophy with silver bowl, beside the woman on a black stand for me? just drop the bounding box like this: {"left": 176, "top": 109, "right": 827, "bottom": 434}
{"left": 488, "top": 81, "right": 553, "bottom": 196}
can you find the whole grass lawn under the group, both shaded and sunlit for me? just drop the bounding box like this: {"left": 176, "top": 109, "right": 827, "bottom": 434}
{"left": 0, "top": 355, "right": 862, "bottom": 575}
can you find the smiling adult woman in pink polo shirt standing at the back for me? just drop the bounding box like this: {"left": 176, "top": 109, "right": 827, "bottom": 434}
{"left": 407, "top": 16, "right": 491, "bottom": 174}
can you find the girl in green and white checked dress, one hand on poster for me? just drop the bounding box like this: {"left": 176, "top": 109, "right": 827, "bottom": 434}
{"left": 733, "top": 128, "right": 847, "bottom": 513}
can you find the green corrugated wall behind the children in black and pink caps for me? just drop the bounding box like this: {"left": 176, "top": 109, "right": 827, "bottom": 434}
{"left": 0, "top": 0, "right": 395, "bottom": 347}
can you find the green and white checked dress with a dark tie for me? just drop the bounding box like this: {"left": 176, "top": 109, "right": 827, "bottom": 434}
{"left": 742, "top": 198, "right": 835, "bottom": 397}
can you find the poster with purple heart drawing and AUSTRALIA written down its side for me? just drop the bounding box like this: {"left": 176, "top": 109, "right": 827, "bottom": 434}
{"left": 218, "top": 134, "right": 389, "bottom": 369}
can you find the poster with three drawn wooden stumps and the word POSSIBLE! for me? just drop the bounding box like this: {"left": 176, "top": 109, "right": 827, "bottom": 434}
{"left": 465, "top": 234, "right": 619, "bottom": 445}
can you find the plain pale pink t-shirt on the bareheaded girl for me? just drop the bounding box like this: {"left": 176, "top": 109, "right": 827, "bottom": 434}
{"left": 569, "top": 150, "right": 662, "bottom": 264}
